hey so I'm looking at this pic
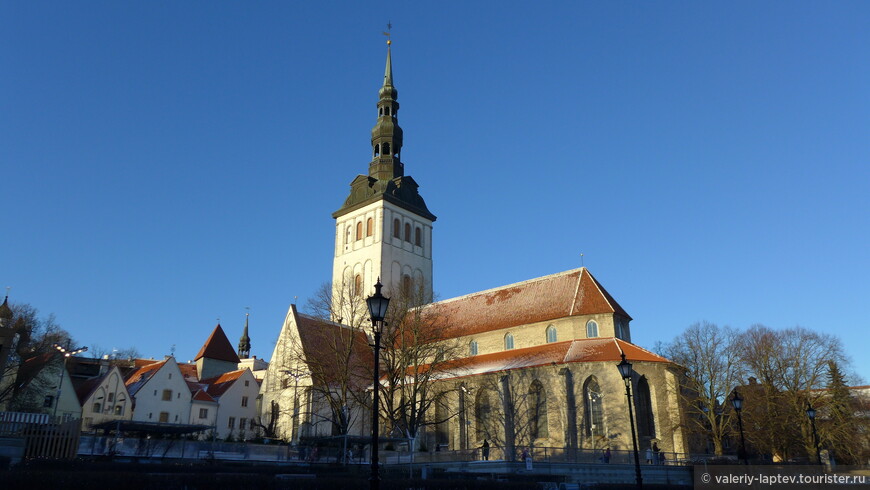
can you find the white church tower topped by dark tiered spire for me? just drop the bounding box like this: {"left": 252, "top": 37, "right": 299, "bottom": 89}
{"left": 332, "top": 41, "right": 435, "bottom": 323}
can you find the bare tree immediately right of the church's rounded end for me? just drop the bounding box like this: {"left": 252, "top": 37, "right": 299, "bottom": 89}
{"left": 660, "top": 322, "right": 741, "bottom": 456}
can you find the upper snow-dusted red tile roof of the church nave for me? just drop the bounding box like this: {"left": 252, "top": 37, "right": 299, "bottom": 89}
{"left": 426, "top": 267, "right": 631, "bottom": 337}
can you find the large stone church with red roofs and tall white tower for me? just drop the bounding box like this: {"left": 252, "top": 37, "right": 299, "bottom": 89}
{"left": 255, "top": 41, "right": 689, "bottom": 460}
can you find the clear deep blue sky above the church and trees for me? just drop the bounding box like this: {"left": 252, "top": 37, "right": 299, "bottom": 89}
{"left": 0, "top": 1, "right": 870, "bottom": 378}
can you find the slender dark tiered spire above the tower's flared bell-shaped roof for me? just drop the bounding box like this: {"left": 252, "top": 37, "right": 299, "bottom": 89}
{"left": 369, "top": 39, "right": 405, "bottom": 180}
